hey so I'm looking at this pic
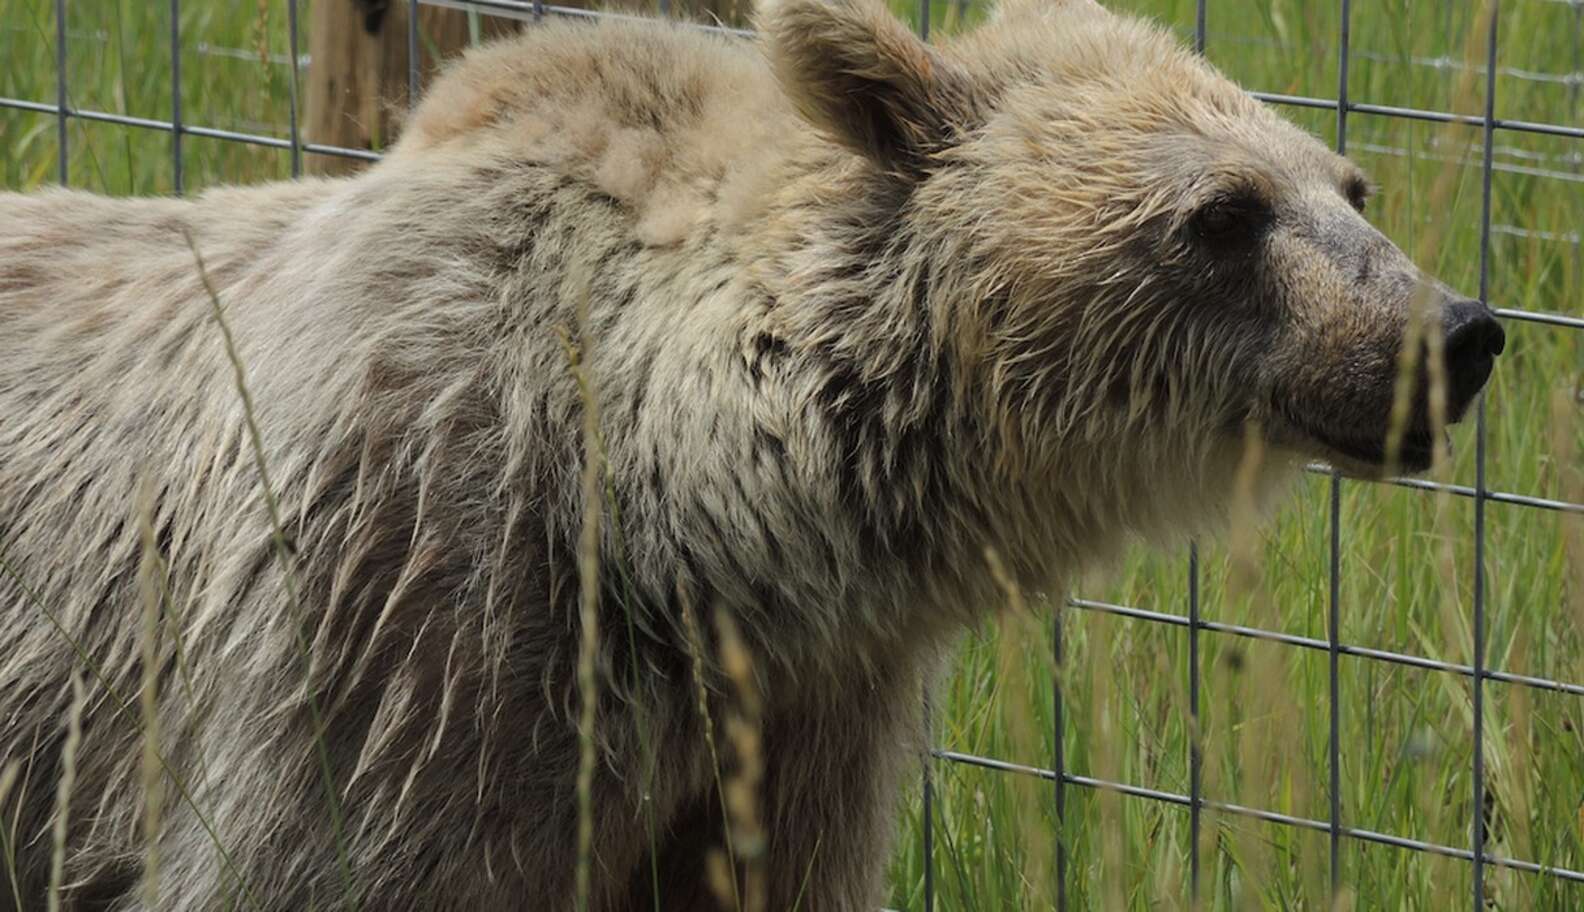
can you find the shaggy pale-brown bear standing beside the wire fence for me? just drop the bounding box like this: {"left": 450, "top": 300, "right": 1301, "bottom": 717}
{"left": 0, "top": 0, "right": 1503, "bottom": 912}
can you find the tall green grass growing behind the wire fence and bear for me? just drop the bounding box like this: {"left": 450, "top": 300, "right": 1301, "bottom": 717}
{"left": 0, "top": 0, "right": 1584, "bottom": 909}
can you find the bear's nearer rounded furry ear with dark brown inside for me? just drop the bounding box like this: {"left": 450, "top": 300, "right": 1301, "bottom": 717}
{"left": 762, "top": 0, "right": 974, "bottom": 177}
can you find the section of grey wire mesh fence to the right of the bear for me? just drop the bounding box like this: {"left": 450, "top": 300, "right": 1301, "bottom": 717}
{"left": 923, "top": 0, "right": 1584, "bottom": 910}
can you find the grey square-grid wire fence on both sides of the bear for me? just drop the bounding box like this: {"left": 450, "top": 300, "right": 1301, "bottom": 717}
{"left": 0, "top": 0, "right": 1584, "bottom": 912}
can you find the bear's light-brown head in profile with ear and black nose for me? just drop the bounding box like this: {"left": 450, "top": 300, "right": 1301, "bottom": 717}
{"left": 763, "top": 0, "right": 1503, "bottom": 475}
